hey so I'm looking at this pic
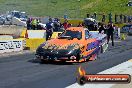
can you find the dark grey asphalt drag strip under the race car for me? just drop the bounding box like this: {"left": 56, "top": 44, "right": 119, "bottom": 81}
{"left": 0, "top": 37, "right": 132, "bottom": 88}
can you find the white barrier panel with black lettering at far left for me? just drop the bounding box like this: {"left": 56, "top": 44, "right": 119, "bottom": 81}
{"left": 0, "top": 39, "right": 23, "bottom": 53}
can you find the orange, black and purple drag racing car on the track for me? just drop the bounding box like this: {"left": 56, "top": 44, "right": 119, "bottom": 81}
{"left": 35, "top": 27, "right": 108, "bottom": 62}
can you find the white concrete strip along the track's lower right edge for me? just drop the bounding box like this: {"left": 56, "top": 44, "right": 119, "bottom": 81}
{"left": 66, "top": 59, "right": 132, "bottom": 88}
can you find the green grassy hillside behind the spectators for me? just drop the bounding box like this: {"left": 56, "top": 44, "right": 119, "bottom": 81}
{"left": 0, "top": 0, "right": 132, "bottom": 18}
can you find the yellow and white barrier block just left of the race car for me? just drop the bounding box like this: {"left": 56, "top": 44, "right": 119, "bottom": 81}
{"left": 20, "top": 30, "right": 46, "bottom": 50}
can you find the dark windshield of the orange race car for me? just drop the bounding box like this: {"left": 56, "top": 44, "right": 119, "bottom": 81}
{"left": 59, "top": 30, "right": 82, "bottom": 39}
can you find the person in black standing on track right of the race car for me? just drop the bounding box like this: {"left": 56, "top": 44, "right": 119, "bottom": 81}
{"left": 107, "top": 23, "right": 114, "bottom": 46}
